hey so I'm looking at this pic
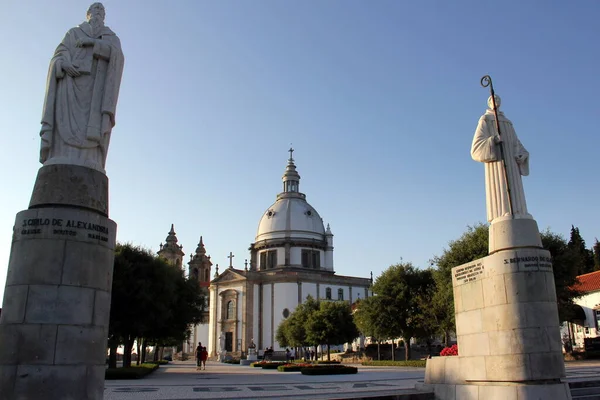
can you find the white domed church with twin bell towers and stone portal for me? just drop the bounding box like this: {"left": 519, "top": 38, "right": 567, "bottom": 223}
{"left": 159, "top": 149, "right": 372, "bottom": 356}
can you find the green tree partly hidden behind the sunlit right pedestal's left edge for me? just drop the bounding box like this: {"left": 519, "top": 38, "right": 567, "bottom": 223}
{"left": 430, "top": 223, "right": 489, "bottom": 346}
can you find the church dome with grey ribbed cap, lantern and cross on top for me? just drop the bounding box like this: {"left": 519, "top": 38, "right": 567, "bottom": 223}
{"left": 256, "top": 149, "right": 325, "bottom": 242}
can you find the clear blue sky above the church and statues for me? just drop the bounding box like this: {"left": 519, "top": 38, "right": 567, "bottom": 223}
{"left": 0, "top": 0, "right": 600, "bottom": 306}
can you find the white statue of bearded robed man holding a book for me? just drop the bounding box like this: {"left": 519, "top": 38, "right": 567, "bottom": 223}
{"left": 40, "top": 3, "right": 124, "bottom": 173}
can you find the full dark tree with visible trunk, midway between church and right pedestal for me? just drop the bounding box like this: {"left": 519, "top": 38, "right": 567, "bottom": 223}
{"left": 373, "top": 263, "right": 435, "bottom": 360}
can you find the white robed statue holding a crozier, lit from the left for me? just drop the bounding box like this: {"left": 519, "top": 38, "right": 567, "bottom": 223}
{"left": 471, "top": 95, "right": 532, "bottom": 223}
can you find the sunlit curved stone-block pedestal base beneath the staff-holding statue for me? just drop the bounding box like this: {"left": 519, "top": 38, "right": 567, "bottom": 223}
{"left": 425, "top": 245, "right": 571, "bottom": 400}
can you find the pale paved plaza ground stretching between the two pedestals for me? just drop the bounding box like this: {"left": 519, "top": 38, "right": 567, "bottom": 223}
{"left": 104, "top": 361, "right": 600, "bottom": 400}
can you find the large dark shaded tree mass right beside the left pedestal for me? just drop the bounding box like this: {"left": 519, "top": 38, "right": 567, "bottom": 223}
{"left": 109, "top": 244, "right": 204, "bottom": 366}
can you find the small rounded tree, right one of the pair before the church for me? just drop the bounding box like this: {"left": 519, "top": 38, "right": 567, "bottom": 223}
{"left": 306, "top": 301, "right": 359, "bottom": 361}
